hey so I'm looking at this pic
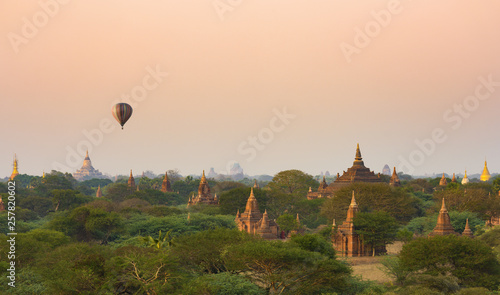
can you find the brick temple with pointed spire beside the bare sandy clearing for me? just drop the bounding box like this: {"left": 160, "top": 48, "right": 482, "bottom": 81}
{"left": 332, "top": 191, "right": 376, "bottom": 257}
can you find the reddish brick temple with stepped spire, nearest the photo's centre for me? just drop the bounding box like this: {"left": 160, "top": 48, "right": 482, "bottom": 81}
{"left": 234, "top": 188, "right": 279, "bottom": 240}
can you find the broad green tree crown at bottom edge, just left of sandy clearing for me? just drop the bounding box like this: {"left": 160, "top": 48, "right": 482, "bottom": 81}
{"left": 223, "top": 240, "right": 351, "bottom": 294}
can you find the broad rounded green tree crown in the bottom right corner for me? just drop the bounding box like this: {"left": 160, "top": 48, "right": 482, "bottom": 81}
{"left": 400, "top": 235, "right": 500, "bottom": 290}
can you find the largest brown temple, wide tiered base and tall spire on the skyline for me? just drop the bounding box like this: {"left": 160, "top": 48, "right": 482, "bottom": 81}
{"left": 307, "top": 143, "right": 384, "bottom": 200}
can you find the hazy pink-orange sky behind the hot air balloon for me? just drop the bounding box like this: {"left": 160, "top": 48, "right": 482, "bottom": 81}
{"left": 0, "top": 0, "right": 500, "bottom": 177}
